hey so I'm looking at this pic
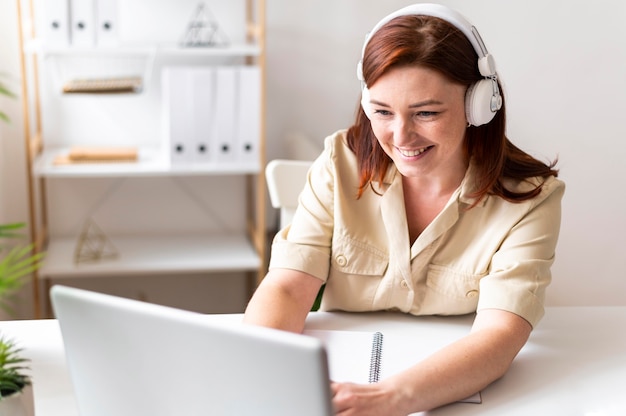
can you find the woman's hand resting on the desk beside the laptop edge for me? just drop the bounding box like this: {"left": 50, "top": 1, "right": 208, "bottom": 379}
{"left": 330, "top": 381, "right": 410, "bottom": 416}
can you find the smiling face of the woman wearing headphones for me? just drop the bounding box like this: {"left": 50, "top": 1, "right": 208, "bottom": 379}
{"left": 369, "top": 66, "right": 467, "bottom": 178}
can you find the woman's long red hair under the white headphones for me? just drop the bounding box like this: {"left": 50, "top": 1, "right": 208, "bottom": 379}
{"left": 347, "top": 15, "right": 558, "bottom": 203}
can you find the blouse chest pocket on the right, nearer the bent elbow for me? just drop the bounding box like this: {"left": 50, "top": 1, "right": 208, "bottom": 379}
{"left": 426, "top": 264, "right": 485, "bottom": 302}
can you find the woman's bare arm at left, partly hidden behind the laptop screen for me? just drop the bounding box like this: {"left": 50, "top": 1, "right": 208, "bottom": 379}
{"left": 244, "top": 269, "right": 323, "bottom": 333}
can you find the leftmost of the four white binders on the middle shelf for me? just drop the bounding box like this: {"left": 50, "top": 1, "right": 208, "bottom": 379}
{"left": 162, "top": 67, "right": 194, "bottom": 165}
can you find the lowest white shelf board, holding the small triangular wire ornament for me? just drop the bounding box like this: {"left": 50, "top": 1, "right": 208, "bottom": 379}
{"left": 39, "top": 235, "right": 261, "bottom": 278}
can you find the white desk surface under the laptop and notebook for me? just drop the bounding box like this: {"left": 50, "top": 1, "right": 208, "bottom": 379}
{"left": 0, "top": 307, "right": 626, "bottom": 416}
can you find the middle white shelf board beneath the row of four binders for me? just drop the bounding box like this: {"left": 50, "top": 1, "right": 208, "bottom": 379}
{"left": 33, "top": 148, "right": 260, "bottom": 178}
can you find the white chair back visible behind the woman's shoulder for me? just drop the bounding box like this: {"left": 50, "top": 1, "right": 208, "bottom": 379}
{"left": 265, "top": 159, "right": 313, "bottom": 228}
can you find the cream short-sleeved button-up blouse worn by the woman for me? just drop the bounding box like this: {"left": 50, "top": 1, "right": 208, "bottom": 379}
{"left": 270, "top": 130, "right": 565, "bottom": 326}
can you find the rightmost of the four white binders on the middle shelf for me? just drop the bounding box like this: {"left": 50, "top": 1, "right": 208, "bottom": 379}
{"left": 235, "top": 66, "right": 261, "bottom": 163}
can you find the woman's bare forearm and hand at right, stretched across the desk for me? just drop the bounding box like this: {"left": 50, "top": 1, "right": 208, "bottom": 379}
{"left": 332, "top": 309, "right": 532, "bottom": 416}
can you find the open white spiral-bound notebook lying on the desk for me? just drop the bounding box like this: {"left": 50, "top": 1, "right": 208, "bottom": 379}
{"left": 304, "top": 329, "right": 482, "bottom": 403}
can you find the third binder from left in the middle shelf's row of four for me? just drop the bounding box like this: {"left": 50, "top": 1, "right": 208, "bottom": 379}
{"left": 213, "top": 66, "right": 237, "bottom": 163}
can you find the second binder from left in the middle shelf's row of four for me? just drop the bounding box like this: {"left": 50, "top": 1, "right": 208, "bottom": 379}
{"left": 190, "top": 67, "right": 215, "bottom": 163}
